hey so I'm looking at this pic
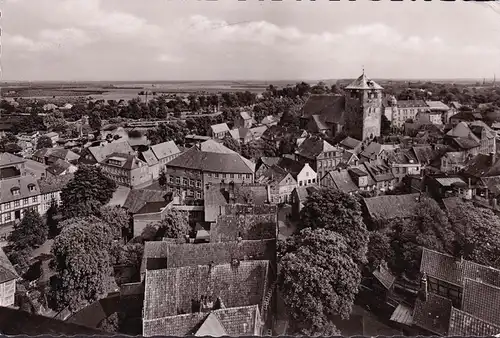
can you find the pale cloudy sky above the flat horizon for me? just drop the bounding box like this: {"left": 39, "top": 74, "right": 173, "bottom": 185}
{"left": 0, "top": 0, "right": 500, "bottom": 81}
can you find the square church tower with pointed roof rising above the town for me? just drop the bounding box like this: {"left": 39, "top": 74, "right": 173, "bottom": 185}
{"left": 345, "top": 70, "right": 384, "bottom": 141}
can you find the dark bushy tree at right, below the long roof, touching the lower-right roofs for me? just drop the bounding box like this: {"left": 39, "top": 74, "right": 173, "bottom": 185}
{"left": 388, "top": 197, "right": 454, "bottom": 277}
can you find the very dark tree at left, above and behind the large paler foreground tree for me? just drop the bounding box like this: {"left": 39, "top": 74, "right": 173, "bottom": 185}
{"left": 61, "top": 165, "right": 116, "bottom": 219}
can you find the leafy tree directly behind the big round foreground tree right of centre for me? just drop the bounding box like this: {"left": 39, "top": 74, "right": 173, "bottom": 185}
{"left": 300, "top": 189, "right": 368, "bottom": 263}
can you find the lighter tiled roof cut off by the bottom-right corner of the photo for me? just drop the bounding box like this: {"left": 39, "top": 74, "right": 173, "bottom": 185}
{"left": 448, "top": 308, "right": 500, "bottom": 337}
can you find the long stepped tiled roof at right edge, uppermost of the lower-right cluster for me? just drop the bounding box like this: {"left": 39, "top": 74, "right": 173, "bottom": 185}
{"left": 420, "top": 248, "right": 500, "bottom": 287}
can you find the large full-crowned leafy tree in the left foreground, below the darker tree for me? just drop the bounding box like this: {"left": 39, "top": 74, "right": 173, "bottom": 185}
{"left": 51, "top": 217, "right": 112, "bottom": 312}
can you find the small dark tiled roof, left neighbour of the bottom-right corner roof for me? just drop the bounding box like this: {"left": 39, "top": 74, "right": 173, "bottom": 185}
{"left": 413, "top": 293, "right": 452, "bottom": 336}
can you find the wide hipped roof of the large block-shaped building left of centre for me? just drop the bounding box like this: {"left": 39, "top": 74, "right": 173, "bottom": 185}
{"left": 167, "top": 141, "right": 255, "bottom": 174}
